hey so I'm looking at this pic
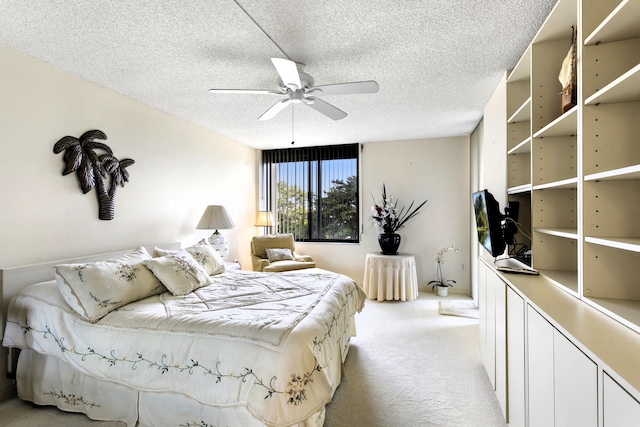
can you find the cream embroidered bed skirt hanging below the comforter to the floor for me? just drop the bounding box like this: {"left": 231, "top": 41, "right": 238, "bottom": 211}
{"left": 17, "top": 317, "right": 355, "bottom": 427}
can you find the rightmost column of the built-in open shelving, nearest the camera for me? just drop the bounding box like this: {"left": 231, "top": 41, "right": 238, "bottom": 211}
{"left": 580, "top": 0, "right": 640, "bottom": 332}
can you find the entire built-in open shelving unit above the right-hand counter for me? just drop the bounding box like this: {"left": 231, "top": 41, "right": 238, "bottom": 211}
{"left": 506, "top": 0, "right": 640, "bottom": 332}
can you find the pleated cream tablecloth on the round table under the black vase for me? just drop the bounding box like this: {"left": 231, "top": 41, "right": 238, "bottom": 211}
{"left": 364, "top": 253, "right": 418, "bottom": 301}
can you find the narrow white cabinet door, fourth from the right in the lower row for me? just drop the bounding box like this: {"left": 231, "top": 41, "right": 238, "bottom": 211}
{"left": 507, "top": 287, "right": 526, "bottom": 427}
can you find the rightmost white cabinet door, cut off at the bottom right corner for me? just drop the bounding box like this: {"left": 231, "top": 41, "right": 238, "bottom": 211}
{"left": 603, "top": 372, "right": 640, "bottom": 427}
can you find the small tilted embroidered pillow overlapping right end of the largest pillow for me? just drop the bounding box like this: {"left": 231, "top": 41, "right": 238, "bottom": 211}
{"left": 144, "top": 249, "right": 211, "bottom": 296}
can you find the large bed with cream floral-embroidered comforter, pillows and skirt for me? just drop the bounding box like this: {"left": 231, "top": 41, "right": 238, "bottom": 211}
{"left": 2, "top": 244, "right": 365, "bottom": 427}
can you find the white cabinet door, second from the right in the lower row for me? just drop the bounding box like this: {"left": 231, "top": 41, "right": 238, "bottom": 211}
{"left": 553, "top": 329, "right": 600, "bottom": 427}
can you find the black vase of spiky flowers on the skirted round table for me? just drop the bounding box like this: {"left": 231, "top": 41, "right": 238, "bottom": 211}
{"left": 371, "top": 184, "right": 428, "bottom": 255}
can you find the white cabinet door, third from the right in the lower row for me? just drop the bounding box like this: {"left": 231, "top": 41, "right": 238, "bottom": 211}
{"left": 527, "top": 305, "right": 555, "bottom": 427}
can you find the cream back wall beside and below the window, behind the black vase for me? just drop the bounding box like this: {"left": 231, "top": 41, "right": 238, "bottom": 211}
{"left": 296, "top": 136, "right": 471, "bottom": 294}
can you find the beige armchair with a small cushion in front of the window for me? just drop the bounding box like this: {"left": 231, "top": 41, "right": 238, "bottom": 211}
{"left": 251, "top": 234, "right": 316, "bottom": 272}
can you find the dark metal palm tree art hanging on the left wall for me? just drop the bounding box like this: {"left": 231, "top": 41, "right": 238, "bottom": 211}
{"left": 53, "top": 130, "right": 134, "bottom": 221}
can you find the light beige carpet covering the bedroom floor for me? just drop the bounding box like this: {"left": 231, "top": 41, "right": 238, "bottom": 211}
{"left": 0, "top": 292, "right": 506, "bottom": 427}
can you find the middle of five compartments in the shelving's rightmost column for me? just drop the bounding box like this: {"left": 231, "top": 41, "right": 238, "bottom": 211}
{"left": 582, "top": 102, "right": 640, "bottom": 176}
